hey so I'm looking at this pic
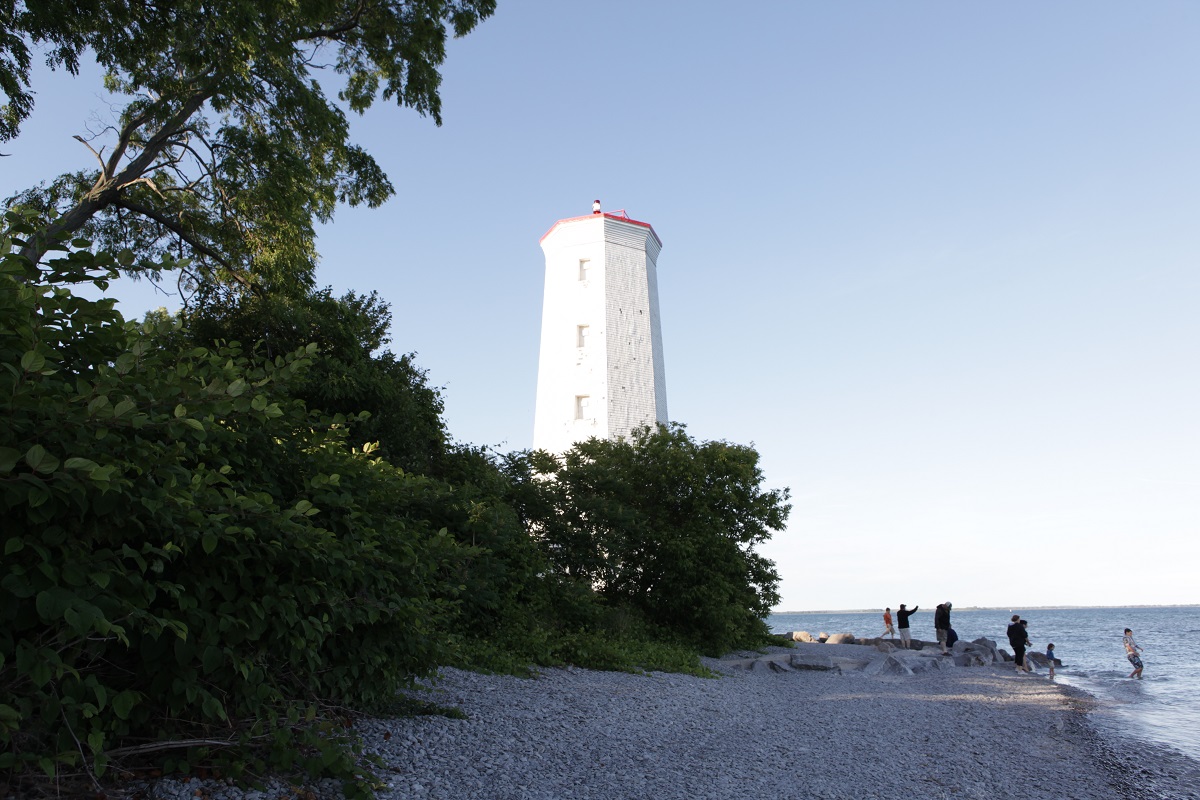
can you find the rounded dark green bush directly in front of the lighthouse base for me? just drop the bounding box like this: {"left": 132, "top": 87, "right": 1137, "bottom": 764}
{"left": 510, "top": 425, "right": 791, "bottom": 655}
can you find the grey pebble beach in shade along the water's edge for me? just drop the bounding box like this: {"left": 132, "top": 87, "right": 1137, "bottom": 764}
{"left": 136, "top": 645, "right": 1200, "bottom": 800}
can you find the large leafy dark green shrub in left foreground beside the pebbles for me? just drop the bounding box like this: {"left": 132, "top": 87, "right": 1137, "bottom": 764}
{"left": 0, "top": 224, "right": 463, "bottom": 796}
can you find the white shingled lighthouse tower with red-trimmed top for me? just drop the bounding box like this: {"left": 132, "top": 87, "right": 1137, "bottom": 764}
{"left": 533, "top": 200, "right": 667, "bottom": 453}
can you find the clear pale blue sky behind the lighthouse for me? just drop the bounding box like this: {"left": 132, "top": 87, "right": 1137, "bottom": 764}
{"left": 0, "top": 0, "right": 1200, "bottom": 610}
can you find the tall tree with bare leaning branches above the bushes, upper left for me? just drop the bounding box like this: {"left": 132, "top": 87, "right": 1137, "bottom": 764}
{"left": 0, "top": 0, "right": 496, "bottom": 293}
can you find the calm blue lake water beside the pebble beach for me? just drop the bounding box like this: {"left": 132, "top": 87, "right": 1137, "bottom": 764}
{"left": 767, "top": 606, "right": 1200, "bottom": 760}
